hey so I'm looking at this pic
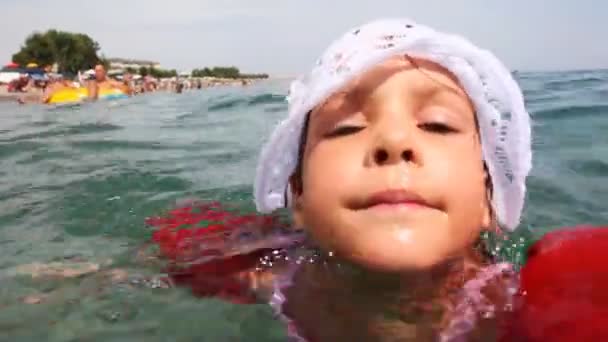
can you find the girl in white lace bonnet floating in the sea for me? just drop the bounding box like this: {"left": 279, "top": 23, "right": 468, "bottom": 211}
{"left": 150, "top": 20, "right": 531, "bottom": 341}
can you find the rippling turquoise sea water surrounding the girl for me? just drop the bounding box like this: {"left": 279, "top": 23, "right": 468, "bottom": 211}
{"left": 0, "top": 71, "right": 608, "bottom": 341}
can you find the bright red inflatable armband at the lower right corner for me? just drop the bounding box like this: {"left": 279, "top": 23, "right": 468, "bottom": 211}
{"left": 503, "top": 226, "right": 608, "bottom": 342}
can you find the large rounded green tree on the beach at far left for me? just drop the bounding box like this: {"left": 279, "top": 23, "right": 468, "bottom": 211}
{"left": 13, "top": 30, "right": 103, "bottom": 73}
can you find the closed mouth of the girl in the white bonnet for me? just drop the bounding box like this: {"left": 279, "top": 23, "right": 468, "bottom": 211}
{"left": 354, "top": 189, "right": 434, "bottom": 210}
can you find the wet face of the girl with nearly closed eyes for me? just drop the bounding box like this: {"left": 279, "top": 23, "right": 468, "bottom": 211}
{"left": 292, "top": 57, "right": 490, "bottom": 271}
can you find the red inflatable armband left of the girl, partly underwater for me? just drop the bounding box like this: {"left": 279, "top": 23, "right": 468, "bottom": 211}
{"left": 146, "top": 202, "right": 294, "bottom": 304}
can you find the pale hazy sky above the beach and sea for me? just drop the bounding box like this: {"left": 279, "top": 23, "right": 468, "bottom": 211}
{"left": 0, "top": 0, "right": 608, "bottom": 75}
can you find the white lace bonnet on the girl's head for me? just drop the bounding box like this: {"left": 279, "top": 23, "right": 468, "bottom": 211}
{"left": 254, "top": 19, "right": 532, "bottom": 230}
